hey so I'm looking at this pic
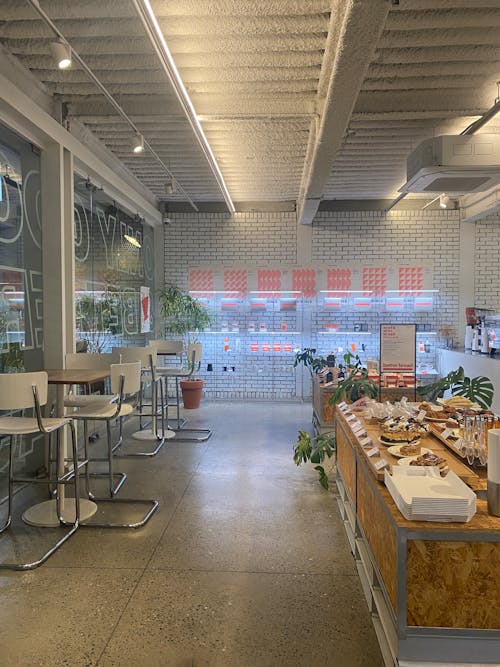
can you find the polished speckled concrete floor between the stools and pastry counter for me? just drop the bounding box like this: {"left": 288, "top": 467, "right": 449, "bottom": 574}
{"left": 0, "top": 402, "right": 383, "bottom": 667}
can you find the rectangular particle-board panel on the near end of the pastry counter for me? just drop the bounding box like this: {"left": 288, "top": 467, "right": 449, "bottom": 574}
{"left": 407, "top": 540, "right": 500, "bottom": 629}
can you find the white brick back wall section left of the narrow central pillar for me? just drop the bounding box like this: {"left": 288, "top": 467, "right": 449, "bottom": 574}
{"left": 165, "top": 212, "right": 297, "bottom": 399}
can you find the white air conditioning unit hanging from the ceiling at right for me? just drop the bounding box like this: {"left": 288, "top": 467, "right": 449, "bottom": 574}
{"left": 400, "top": 134, "right": 500, "bottom": 195}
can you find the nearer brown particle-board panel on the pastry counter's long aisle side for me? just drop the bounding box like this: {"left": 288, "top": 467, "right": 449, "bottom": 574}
{"left": 356, "top": 466, "right": 398, "bottom": 612}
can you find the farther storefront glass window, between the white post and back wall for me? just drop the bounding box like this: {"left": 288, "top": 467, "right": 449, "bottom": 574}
{"left": 75, "top": 176, "right": 154, "bottom": 352}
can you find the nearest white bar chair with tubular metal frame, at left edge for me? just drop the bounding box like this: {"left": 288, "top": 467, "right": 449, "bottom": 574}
{"left": 0, "top": 371, "right": 81, "bottom": 570}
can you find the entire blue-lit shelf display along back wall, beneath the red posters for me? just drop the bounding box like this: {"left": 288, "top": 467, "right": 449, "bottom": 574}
{"left": 190, "top": 290, "right": 439, "bottom": 399}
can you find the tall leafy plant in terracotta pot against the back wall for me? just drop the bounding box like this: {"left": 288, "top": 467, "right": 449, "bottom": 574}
{"left": 158, "top": 285, "right": 212, "bottom": 409}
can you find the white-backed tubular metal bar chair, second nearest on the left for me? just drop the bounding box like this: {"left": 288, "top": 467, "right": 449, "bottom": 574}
{"left": 71, "top": 361, "right": 158, "bottom": 528}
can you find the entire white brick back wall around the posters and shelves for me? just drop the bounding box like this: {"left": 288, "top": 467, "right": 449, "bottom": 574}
{"left": 165, "top": 210, "right": 500, "bottom": 399}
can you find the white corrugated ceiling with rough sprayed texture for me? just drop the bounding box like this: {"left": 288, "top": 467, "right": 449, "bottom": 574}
{"left": 0, "top": 0, "right": 500, "bottom": 217}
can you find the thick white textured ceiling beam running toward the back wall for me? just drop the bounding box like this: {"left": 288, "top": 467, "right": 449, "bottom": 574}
{"left": 297, "top": 0, "right": 391, "bottom": 224}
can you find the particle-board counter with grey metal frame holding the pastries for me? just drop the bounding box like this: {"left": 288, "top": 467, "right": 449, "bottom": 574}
{"left": 336, "top": 411, "right": 500, "bottom": 667}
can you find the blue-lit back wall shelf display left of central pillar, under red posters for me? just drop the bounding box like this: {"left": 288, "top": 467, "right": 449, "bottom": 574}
{"left": 190, "top": 291, "right": 303, "bottom": 399}
